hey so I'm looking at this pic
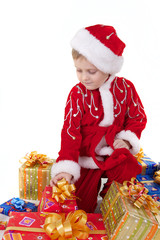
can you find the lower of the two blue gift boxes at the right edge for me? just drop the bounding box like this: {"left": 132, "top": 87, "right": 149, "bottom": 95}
{"left": 137, "top": 174, "right": 160, "bottom": 201}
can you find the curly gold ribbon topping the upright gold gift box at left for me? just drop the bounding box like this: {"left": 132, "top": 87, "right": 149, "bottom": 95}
{"left": 20, "top": 151, "right": 53, "bottom": 167}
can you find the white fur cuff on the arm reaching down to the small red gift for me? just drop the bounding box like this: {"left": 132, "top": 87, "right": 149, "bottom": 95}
{"left": 51, "top": 160, "right": 80, "bottom": 182}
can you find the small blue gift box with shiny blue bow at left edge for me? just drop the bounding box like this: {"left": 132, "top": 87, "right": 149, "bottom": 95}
{"left": 0, "top": 198, "right": 37, "bottom": 216}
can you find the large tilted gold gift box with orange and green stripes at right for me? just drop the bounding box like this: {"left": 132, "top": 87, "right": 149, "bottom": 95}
{"left": 100, "top": 182, "right": 160, "bottom": 240}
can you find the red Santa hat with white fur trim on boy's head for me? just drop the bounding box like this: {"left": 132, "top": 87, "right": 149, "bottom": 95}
{"left": 71, "top": 24, "right": 125, "bottom": 74}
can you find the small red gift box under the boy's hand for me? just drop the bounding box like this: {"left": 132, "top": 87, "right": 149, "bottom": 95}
{"left": 38, "top": 186, "right": 78, "bottom": 213}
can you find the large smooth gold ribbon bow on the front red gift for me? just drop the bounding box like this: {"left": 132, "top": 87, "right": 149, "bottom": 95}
{"left": 44, "top": 210, "right": 90, "bottom": 240}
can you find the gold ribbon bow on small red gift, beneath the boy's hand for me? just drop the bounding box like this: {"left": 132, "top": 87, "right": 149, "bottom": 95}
{"left": 52, "top": 178, "right": 76, "bottom": 203}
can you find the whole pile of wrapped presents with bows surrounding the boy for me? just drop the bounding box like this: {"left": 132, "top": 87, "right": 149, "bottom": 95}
{"left": 0, "top": 150, "right": 160, "bottom": 240}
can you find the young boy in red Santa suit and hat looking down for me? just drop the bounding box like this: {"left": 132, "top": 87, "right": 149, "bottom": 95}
{"left": 51, "top": 25, "right": 146, "bottom": 212}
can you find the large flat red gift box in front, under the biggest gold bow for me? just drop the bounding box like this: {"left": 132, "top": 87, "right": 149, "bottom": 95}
{"left": 2, "top": 212, "right": 107, "bottom": 240}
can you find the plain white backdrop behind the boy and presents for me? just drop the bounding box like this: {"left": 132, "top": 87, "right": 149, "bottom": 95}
{"left": 0, "top": 0, "right": 160, "bottom": 203}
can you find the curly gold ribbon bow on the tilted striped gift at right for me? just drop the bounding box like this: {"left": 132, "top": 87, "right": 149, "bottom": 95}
{"left": 120, "top": 178, "right": 160, "bottom": 214}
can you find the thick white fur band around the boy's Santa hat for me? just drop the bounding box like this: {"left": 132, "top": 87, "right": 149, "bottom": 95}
{"left": 71, "top": 28, "right": 123, "bottom": 74}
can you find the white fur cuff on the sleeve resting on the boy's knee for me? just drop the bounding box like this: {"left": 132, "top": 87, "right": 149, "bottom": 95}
{"left": 116, "top": 130, "right": 140, "bottom": 155}
